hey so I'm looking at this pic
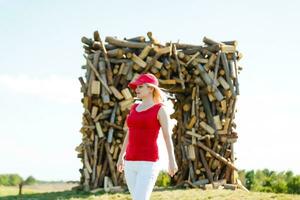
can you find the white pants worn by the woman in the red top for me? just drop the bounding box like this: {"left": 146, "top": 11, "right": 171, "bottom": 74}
{"left": 124, "top": 160, "right": 160, "bottom": 200}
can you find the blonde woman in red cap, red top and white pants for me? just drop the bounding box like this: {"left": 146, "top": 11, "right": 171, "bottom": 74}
{"left": 117, "top": 73, "right": 178, "bottom": 200}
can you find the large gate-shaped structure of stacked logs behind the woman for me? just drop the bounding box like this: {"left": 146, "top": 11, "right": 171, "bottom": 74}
{"left": 76, "top": 31, "right": 242, "bottom": 190}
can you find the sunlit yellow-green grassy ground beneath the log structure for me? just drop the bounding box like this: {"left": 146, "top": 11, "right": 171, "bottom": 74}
{"left": 0, "top": 183, "right": 300, "bottom": 200}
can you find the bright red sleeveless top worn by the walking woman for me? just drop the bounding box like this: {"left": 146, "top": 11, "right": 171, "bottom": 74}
{"left": 124, "top": 103, "right": 162, "bottom": 162}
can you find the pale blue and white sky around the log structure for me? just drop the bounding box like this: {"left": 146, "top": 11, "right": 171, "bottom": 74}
{"left": 0, "top": 0, "right": 300, "bottom": 181}
